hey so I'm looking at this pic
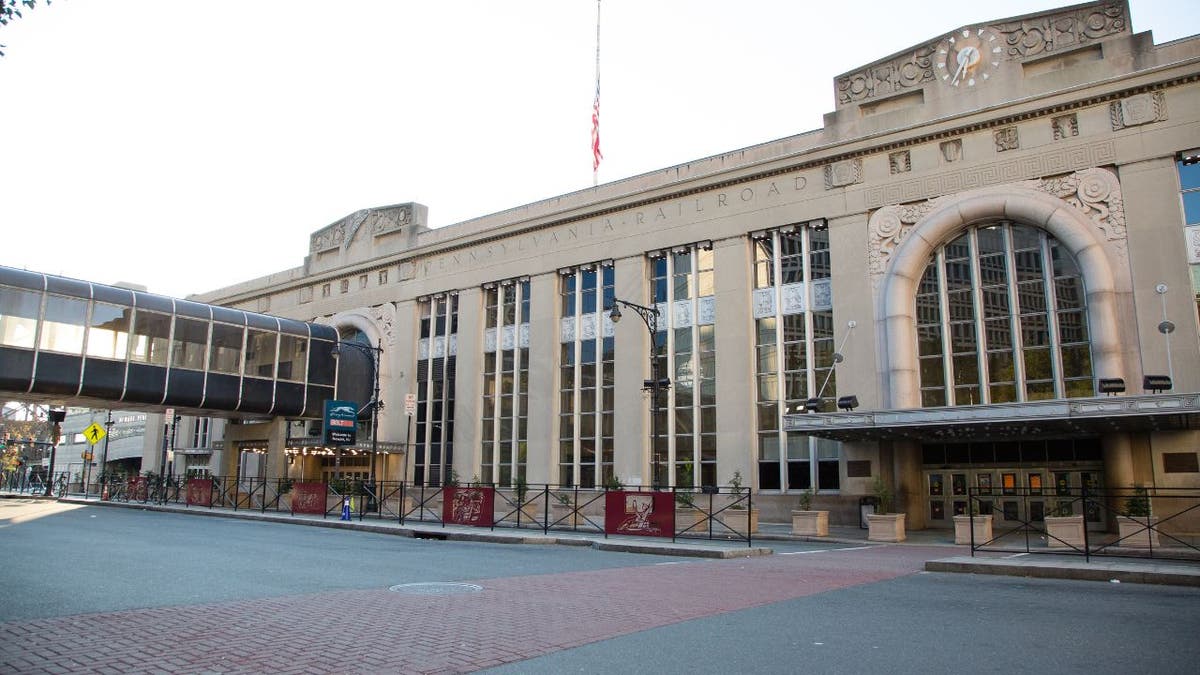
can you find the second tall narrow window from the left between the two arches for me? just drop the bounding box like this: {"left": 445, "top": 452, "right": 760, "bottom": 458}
{"left": 480, "top": 279, "right": 529, "bottom": 486}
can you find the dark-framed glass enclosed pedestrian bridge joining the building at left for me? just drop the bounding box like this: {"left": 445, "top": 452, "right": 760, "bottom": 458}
{"left": 0, "top": 267, "right": 364, "bottom": 418}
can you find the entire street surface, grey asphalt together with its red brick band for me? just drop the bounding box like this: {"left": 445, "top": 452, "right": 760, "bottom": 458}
{"left": 0, "top": 500, "right": 1200, "bottom": 674}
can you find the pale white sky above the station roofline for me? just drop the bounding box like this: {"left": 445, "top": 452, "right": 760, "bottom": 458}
{"left": 0, "top": 0, "right": 1200, "bottom": 297}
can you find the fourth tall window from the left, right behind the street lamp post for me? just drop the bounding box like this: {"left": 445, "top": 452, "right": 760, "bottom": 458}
{"left": 650, "top": 241, "right": 716, "bottom": 488}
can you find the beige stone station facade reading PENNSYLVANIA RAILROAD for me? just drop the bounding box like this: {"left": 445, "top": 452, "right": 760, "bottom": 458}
{"left": 193, "top": 1, "right": 1200, "bottom": 527}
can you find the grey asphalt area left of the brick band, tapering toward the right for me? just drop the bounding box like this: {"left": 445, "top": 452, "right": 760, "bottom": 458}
{"left": 0, "top": 500, "right": 686, "bottom": 621}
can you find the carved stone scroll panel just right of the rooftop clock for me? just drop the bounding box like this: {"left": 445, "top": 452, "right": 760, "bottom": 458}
{"left": 991, "top": 2, "right": 1129, "bottom": 59}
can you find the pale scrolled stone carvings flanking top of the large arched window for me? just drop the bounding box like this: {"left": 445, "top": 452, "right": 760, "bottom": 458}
{"left": 868, "top": 168, "right": 1127, "bottom": 283}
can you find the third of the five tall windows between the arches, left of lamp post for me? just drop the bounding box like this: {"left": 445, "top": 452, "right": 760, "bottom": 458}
{"left": 558, "top": 262, "right": 617, "bottom": 488}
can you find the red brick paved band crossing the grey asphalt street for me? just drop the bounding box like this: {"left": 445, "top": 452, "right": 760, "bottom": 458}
{"left": 0, "top": 546, "right": 944, "bottom": 674}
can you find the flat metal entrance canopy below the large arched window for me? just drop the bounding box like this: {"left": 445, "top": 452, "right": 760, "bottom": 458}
{"left": 784, "top": 394, "right": 1200, "bottom": 442}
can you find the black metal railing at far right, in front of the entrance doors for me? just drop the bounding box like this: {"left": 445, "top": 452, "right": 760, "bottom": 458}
{"left": 956, "top": 486, "right": 1200, "bottom": 561}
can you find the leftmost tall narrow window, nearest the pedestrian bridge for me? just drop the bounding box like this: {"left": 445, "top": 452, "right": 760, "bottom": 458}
{"left": 413, "top": 293, "right": 458, "bottom": 485}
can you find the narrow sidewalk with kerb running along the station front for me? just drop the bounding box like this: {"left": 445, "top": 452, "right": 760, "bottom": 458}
{"left": 16, "top": 494, "right": 1200, "bottom": 586}
